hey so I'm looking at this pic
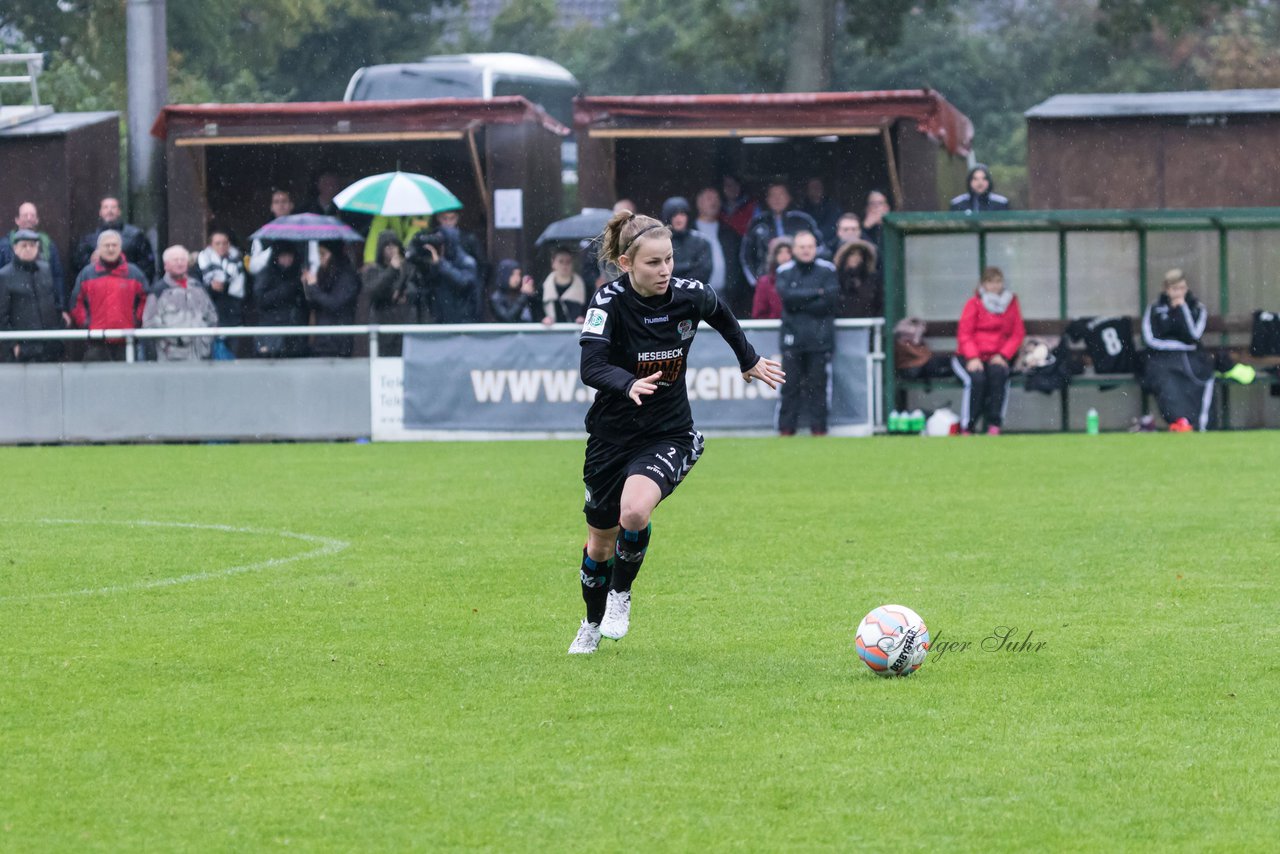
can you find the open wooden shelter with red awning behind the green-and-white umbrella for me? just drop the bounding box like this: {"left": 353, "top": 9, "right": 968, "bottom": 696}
{"left": 151, "top": 97, "right": 570, "bottom": 259}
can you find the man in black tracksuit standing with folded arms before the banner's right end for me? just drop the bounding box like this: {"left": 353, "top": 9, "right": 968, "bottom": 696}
{"left": 777, "top": 232, "right": 840, "bottom": 435}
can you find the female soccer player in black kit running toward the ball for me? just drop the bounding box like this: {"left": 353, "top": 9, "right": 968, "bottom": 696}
{"left": 568, "top": 210, "right": 783, "bottom": 654}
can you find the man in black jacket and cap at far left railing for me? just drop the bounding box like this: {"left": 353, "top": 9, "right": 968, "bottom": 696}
{"left": 0, "top": 228, "right": 69, "bottom": 362}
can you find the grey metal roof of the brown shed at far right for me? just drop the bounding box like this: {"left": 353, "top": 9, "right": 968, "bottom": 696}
{"left": 1024, "top": 88, "right": 1280, "bottom": 119}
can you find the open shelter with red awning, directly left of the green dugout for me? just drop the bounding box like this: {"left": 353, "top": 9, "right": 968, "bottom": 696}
{"left": 573, "top": 90, "right": 973, "bottom": 213}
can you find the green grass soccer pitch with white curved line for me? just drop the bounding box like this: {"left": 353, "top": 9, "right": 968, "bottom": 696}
{"left": 0, "top": 433, "right": 1280, "bottom": 851}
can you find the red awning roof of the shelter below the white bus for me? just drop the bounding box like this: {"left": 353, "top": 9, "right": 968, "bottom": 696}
{"left": 151, "top": 96, "right": 570, "bottom": 146}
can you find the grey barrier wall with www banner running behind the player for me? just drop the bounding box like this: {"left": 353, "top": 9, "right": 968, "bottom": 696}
{"left": 0, "top": 320, "right": 882, "bottom": 444}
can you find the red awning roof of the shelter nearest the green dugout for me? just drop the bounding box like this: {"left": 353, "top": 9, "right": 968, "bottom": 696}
{"left": 573, "top": 90, "right": 973, "bottom": 155}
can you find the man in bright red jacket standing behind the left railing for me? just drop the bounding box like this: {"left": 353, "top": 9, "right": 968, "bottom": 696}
{"left": 72, "top": 229, "right": 147, "bottom": 362}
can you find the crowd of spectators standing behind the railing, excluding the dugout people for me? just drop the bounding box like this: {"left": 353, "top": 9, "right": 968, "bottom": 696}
{"left": 0, "top": 173, "right": 888, "bottom": 362}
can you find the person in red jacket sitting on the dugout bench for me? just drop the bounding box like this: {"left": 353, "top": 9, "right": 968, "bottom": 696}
{"left": 951, "top": 266, "right": 1027, "bottom": 435}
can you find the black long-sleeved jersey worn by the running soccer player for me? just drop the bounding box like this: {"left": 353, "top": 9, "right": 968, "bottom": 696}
{"left": 579, "top": 275, "right": 759, "bottom": 444}
